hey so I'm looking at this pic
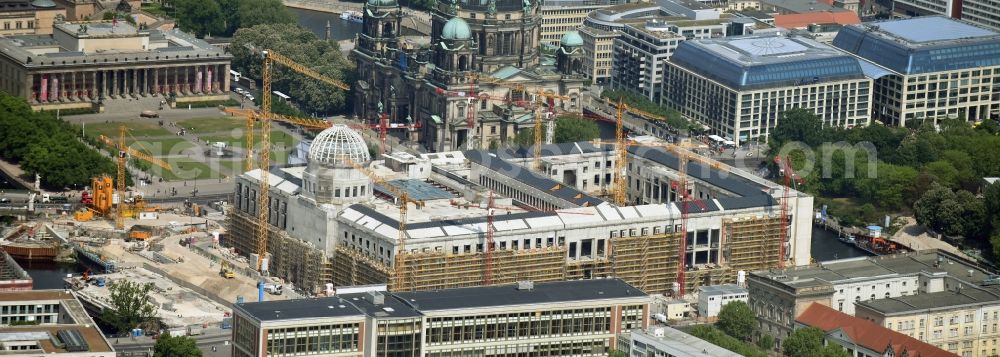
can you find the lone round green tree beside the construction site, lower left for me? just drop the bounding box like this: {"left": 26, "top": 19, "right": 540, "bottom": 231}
{"left": 102, "top": 280, "right": 156, "bottom": 332}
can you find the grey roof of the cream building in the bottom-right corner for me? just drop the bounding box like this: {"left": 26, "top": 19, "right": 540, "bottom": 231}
{"left": 856, "top": 288, "right": 1000, "bottom": 315}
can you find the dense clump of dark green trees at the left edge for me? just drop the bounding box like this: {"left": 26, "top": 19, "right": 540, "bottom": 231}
{"left": 0, "top": 92, "right": 116, "bottom": 190}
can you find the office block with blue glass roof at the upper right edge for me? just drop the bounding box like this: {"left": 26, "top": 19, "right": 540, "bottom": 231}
{"left": 833, "top": 16, "right": 1000, "bottom": 126}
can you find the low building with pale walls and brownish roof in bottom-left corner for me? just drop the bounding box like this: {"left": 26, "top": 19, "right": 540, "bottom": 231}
{"left": 0, "top": 290, "right": 117, "bottom": 357}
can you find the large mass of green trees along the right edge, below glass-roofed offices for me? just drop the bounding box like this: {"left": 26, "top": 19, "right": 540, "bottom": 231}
{"left": 769, "top": 109, "right": 1000, "bottom": 246}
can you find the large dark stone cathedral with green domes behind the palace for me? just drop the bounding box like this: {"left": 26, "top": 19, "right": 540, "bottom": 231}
{"left": 353, "top": 0, "right": 586, "bottom": 152}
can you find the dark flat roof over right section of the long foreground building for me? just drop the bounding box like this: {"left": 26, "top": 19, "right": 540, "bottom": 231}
{"left": 395, "top": 279, "right": 649, "bottom": 311}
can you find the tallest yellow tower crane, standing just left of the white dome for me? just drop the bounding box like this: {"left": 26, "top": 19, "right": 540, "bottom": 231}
{"left": 247, "top": 50, "right": 351, "bottom": 273}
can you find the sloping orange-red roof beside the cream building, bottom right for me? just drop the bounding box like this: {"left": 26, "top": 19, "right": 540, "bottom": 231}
{"left": 795, "top": 304, "right": 952, "bottom": 357}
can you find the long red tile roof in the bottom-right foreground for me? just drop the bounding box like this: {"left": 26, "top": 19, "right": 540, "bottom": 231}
{"left": 795, "top": 303, "right": 957, "bottom": 357}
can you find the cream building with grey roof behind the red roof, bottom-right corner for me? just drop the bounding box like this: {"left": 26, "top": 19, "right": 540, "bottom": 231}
{"left": 855, "top": 282, "right": 1000, "bottom": 356}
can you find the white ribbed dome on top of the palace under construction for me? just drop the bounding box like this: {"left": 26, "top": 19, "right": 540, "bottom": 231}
{"left": 309, "top": 124, "right": 371, "bottom": 166}
